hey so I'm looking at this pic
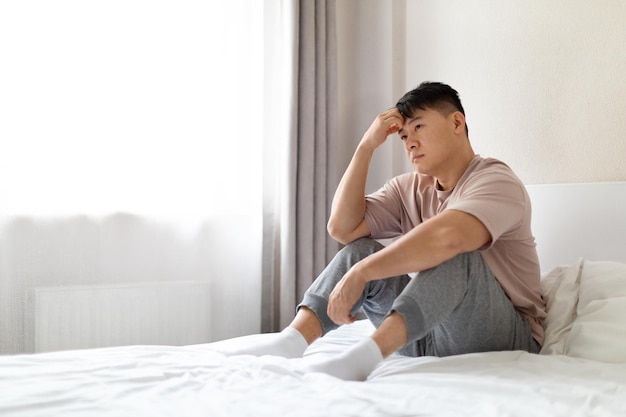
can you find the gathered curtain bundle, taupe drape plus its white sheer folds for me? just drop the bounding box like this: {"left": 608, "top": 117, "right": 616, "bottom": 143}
{"left": 262, "top": 0, "right": 338, "bottom": 331}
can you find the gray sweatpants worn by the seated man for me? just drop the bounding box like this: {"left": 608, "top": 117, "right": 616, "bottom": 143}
{"left": 298, "top": 238, "right": 540, "bottom": 356}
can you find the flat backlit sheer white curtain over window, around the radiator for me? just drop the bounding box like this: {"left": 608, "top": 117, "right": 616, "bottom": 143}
{"left": 0, "top": 0, "right": 264, "bottom": 353}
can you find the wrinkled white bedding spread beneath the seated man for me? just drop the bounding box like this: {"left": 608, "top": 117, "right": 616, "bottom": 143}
{"left": 0, "top": 321, "right": 626, "bottom": 417}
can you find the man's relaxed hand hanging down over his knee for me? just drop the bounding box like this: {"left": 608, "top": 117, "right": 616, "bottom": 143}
{"left": 327, "top": 264, "right": 365, "bottom": 325}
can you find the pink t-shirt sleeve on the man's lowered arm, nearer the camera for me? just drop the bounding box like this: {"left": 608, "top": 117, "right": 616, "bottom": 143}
{"left": 446, "top": 174, "right": 527, "bottom": 246}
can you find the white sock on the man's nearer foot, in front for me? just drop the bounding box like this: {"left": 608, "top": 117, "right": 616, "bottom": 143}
{"left": 300, "top": 337, "right": 383, "bottom": 381}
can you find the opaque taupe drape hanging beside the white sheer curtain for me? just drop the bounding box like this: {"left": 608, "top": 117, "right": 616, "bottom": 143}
{"left": 295, "top": 0, "right": 337, "bottom": 299}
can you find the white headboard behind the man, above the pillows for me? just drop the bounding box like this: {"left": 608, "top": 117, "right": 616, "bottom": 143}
{"left": 526, "top": 182, "right": 626, "bottom": 273}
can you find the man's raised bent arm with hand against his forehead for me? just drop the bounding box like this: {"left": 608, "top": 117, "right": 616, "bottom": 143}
{"left": 327, "top": 108, "right": 403, "bottom": 244}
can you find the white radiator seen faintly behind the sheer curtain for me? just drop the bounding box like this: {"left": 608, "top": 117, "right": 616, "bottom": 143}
{"left": 34, "top": 281, "right": 211, "bottom": 352}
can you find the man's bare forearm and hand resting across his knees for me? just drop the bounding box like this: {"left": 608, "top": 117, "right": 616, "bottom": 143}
{"left": 328, "top": 210, "right": 491, "bottom": 324}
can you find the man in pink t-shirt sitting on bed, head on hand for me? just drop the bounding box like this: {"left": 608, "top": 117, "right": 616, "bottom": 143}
{"left": 222, "top": 82, "right": 545, "bottom": 380}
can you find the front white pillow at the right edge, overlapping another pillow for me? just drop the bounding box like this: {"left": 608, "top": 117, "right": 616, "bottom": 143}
{"left": 566, "top": 261, "right": 626, "bottom": 363}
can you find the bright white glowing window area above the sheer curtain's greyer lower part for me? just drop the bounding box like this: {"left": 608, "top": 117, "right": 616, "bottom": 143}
{"left": 0, "top": 0, "right": 263, "bottom": 221}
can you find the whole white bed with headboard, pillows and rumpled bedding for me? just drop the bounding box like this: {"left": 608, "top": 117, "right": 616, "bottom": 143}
{"left": 0, "top": 183, "right": 626, "bottom": 417}
